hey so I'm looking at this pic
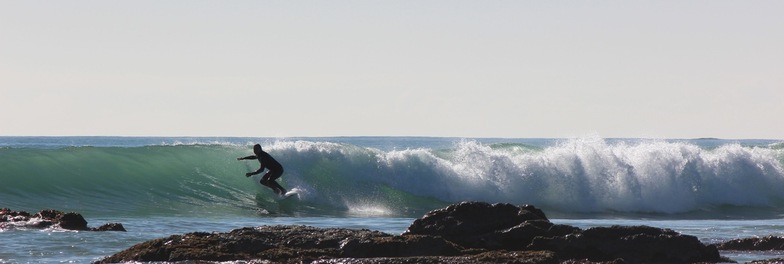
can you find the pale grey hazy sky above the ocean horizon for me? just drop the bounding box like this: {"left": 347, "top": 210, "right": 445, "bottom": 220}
{"left": 0, "top": 0, "right": 784, "bottom": 139}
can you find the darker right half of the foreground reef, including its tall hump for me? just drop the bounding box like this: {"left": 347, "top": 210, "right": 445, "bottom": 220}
{"left": 404, "top": 202, "right": 722, "bottom": 263}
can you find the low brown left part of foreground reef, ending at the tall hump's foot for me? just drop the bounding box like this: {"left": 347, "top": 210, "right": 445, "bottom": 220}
{"left": 95, "top": 226, "right": 462, "bottom": 263}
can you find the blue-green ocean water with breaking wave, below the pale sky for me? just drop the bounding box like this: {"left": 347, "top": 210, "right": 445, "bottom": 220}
{"left": 0, "top": 136, "right": 784, "bottom": 263}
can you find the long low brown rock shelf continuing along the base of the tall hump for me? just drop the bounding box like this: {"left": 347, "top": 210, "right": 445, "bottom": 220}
{"left": 98, "top": 223, "right": 558, "bottom": 263}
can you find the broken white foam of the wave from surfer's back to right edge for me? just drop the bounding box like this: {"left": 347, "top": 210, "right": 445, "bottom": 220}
{"left": 237, "top": 137, "right": 784, "bottom": 213}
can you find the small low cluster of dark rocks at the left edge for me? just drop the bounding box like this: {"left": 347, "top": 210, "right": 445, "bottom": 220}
{"left": 0, "top": 208, "right": 125, "bottom": 231}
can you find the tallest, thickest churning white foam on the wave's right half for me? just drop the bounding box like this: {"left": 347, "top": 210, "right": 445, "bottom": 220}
{"left": 374, "top": 138, "right": 784, "bottom": 213}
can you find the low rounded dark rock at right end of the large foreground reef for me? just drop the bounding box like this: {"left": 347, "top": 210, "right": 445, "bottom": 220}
{"left": 529, "top": 226, "right": 726, "bottom": 263}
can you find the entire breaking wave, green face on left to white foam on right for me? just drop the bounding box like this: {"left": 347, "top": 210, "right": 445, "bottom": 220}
{"left": 0, "top": 137, "right": 784, "bottom": 217}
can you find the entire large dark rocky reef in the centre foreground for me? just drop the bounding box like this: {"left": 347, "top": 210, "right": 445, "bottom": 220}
{"left": 98, "top": 202, "right": 731, "bottom": 263}
